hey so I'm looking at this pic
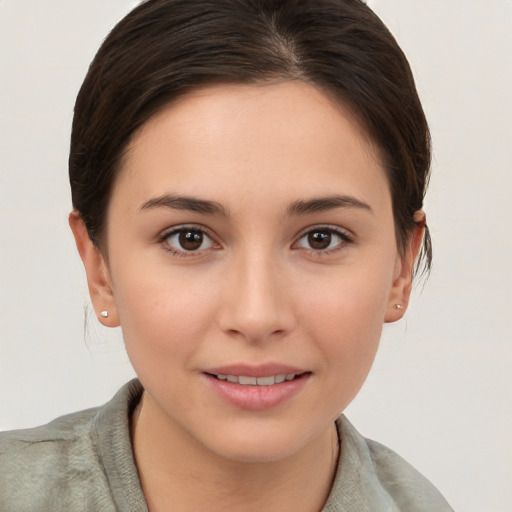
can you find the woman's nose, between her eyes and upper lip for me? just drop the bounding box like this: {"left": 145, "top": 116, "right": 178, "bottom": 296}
{"left": 219, "top": 250, "right": 296, "bottom": 342}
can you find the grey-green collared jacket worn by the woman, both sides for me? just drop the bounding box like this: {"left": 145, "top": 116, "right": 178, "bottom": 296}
{"left": 0, "top": 380, "right": 452, "bottom": 512}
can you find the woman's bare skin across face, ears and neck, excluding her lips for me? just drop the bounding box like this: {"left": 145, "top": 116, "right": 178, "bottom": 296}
{"left": 70, "top": 82, "right": 422, "bottom": 511}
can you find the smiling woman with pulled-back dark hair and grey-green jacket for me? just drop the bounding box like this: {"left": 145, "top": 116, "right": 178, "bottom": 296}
{"left": 0, "top": 0, "right": 451, "bottom": 511}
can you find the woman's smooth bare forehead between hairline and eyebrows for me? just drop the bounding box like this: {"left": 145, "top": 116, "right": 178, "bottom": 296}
{"left": 114, "top": 82, "right": 388, "bottom": 214}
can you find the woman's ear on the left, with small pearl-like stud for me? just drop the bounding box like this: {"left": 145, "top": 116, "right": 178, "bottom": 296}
{"left": 69, "top": 210, "right": 119, "bottom": 327}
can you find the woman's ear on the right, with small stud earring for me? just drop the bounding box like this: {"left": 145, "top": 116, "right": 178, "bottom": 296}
{"left": 384, "top": 210, "right": 425, "bottom": 323}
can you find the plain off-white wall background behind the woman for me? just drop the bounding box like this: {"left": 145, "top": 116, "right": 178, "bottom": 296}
{"left": 0, "top": 0, "right": 512, "bottom": 512}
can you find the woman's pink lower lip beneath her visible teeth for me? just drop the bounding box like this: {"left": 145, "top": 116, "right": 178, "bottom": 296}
{"left": 204, "top": 374, "right": 310, "bottom": 411}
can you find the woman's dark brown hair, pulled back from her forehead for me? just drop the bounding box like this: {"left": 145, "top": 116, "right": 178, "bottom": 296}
{"left": 69, "top": 0, "right": 431, "bottom": 269}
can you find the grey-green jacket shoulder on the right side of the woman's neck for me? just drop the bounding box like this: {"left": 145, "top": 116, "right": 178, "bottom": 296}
{"left": 325, "top": 416, "right": 453, "bottom": 512}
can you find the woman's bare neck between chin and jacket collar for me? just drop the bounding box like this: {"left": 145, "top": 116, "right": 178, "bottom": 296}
{"left": 132, "top": 394, "right": 339, "bottom": 512}
